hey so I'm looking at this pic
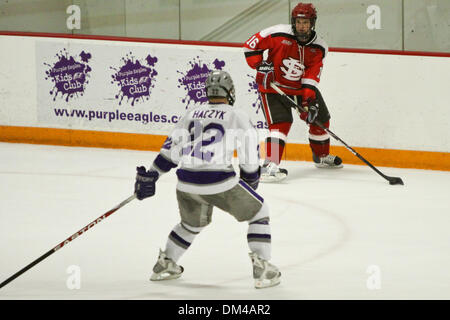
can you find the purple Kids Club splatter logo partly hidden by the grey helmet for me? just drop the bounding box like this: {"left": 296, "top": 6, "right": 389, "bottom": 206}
{"left": 177, "top": 56, "right": 225, "bottom": 109}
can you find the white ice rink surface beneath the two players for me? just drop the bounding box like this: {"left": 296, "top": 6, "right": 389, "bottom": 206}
{"left": 0, "top": 143, "right": 450, "bottom": 300}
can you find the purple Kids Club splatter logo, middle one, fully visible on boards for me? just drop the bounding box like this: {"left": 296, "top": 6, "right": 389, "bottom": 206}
{"left": 111, "top": 52, "right": 158, "bottom": 106}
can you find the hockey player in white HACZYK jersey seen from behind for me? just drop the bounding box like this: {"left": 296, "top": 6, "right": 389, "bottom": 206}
{"left": 135, "top": 70, "right": 281, "bottom": 288}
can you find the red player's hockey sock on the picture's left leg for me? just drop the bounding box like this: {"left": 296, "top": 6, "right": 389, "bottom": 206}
{"left": 266, "top": 122, "right": 292, "bottom": 165}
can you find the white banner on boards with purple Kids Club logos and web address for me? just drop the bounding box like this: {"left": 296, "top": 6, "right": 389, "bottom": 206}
{"left": 36, "top": 39, "right": 267, "bottom": 134}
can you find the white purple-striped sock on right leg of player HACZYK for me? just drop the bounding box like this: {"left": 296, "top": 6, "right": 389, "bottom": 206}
{"left": 247, "top": 204, "right": 272, "bottom": 261}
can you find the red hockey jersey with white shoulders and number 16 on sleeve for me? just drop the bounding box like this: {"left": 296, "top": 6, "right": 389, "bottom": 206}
{"left": 244, "top": 24, "right": 328, "bottom": 95}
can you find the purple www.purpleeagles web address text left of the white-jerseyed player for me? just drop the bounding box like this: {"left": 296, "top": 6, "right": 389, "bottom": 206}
{"left": 53, "top": 108, "right": 179, "bottom": 124}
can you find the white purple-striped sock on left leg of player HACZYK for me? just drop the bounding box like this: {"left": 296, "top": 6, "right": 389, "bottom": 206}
{"left": 165, "top": 222, "right": 203, "bottom": 262}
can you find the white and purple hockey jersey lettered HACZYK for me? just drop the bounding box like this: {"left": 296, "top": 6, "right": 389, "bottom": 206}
{"left": 152, "top": 104, "right": 259, "bottom": 194}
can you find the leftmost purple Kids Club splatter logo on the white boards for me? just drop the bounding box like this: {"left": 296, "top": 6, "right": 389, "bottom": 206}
{"left": 44, "top": 49, "right": 92, "bottom": 102}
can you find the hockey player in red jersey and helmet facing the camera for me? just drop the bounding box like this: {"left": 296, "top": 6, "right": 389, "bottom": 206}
{"left": 244, "top": 3, "right": 342, "bottom": 181}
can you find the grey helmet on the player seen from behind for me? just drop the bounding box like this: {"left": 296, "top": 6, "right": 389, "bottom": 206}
{"left": 205, "top": 70, "right": 236, "bottom": 105}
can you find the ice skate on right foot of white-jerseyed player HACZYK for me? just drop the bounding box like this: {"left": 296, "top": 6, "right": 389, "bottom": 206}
{"left": 249, "top": 252, "right": 281, "bottom": 289}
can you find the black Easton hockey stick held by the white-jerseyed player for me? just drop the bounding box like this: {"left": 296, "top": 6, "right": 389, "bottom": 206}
{"left": 0, "top": 194, "right": 136, "bottom": 288}
